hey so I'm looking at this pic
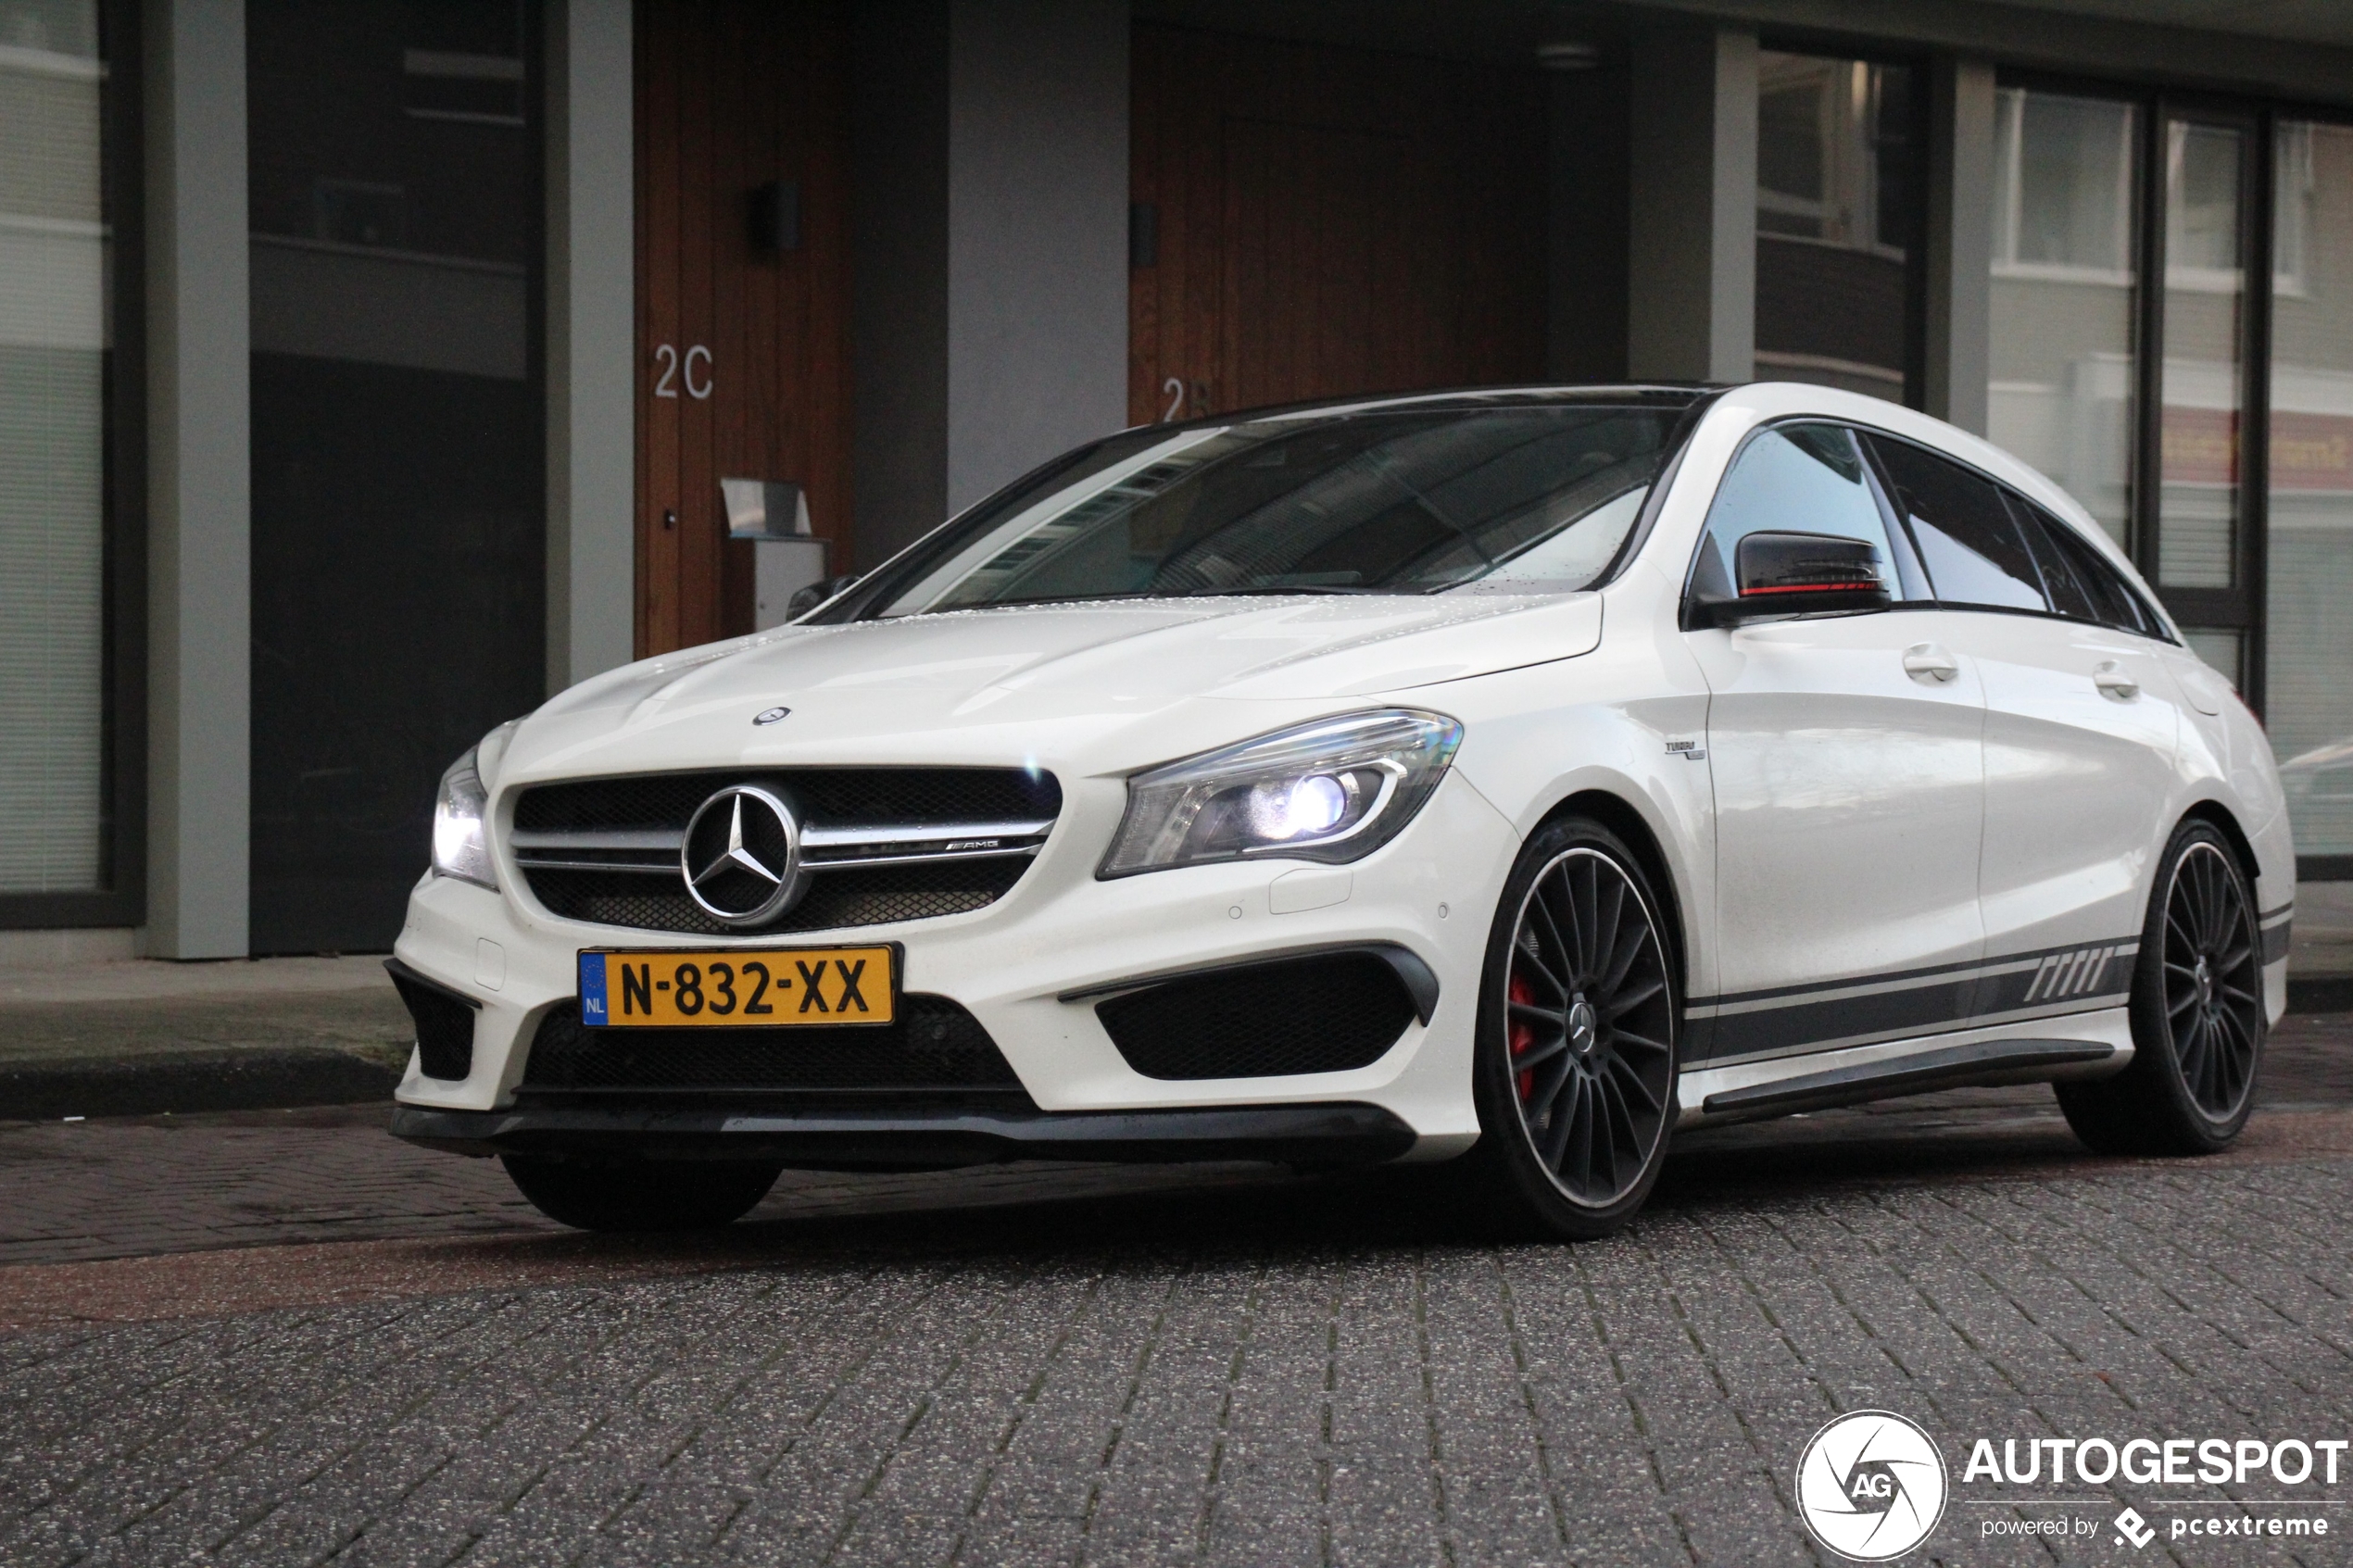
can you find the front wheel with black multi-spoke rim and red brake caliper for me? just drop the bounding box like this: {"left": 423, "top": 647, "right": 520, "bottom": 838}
{"left": 1471, "top": 818, "right": 1680, "bottom": 1239}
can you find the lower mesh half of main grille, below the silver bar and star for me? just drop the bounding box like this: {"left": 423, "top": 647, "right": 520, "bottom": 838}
{"left": 527, "top": 856, "right": 1028, "bottom": 935}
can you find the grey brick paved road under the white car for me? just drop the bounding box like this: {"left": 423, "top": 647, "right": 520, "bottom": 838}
{"left": 0, "top": 1021, "right": 2353, "bottom": 1568}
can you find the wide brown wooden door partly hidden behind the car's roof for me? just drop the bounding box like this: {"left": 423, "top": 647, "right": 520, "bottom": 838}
{"left": 1127, "top": 23, "right": 1546, "bottom": 423}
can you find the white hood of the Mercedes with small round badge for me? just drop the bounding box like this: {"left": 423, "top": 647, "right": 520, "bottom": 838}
{"left": 484, "top": 593, "right": 1603, "bottom": 781}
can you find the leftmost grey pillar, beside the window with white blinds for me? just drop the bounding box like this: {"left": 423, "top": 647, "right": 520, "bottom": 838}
{"left": 144, "top": 0, "right": 252, "bottom": 960}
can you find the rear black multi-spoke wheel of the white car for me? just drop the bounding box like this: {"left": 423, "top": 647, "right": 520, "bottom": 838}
{"left": 2057, "top": 821, "right": 2266, "bottom": 1154}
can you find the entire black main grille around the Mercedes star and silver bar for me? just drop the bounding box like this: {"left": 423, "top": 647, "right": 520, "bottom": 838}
{"left": 515, "top": 769, "right": 1062, "bottom": 935}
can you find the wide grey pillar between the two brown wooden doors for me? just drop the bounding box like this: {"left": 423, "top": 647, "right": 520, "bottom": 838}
{"left": 851, "top": 0, "right": 1129, "bottom": 567}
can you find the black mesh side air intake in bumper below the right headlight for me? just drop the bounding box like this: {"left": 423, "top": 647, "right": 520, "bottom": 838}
{"left": 1094, "top": 952, "right": 1415, "bottom": 1079}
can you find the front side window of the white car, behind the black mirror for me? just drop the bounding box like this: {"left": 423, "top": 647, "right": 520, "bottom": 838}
{"left": 1692, "top": 425, "right": 1906, "bottom": 602}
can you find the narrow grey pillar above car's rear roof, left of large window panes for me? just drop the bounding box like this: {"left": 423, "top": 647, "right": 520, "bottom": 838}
{"left": 1925, "top": 56, "right": 1993, "bottom": 435}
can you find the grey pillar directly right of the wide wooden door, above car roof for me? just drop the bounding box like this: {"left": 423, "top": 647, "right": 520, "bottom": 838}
{"left": 1626, "top": 19, "right": 1757, "bottom": 381}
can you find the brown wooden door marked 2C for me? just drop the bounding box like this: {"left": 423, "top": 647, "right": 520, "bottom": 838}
{"left": 635, "top": 0, "right": 849, "bottom": 659}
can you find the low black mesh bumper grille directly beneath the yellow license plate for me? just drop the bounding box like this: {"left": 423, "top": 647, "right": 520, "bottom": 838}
{"left": 520, "top": 995, "right": 1028, "bottom": 1105}
